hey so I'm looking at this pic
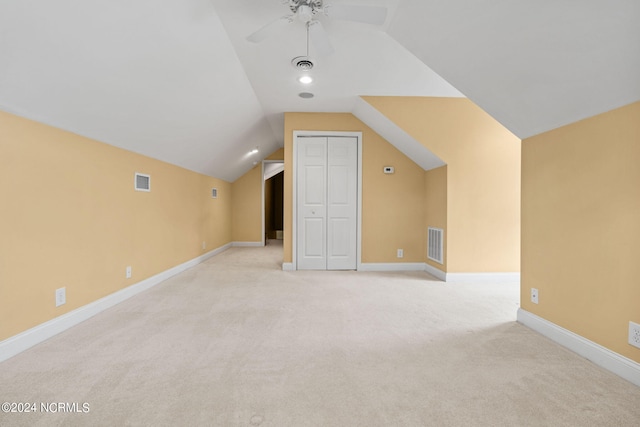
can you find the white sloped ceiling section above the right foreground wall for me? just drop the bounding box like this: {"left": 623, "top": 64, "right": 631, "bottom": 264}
{"left": 388, "top": 0, "right": 640, "bottom": 139}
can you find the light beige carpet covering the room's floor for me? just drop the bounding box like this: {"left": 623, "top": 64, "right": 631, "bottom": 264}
{"left": 0, "top": 245, "right": 640, "bottom": 426}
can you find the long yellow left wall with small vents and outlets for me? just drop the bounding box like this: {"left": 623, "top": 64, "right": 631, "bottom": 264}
{"left": 0, "top": 112, "right": 231, "bottom": 340}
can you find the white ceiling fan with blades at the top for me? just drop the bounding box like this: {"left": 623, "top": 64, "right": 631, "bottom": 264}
{"left": 247, "top": 0, "right": 387, "bottom": 55}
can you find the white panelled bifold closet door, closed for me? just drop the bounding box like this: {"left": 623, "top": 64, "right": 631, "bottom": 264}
{"left": 296, "top": 136, "right": 358, "bottom": 270}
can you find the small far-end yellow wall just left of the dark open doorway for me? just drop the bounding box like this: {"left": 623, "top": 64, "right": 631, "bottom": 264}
{"left": 231, "top": 164, "right": 262, "bottom": 242}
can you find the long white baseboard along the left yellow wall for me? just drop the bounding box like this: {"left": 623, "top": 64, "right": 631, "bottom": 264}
{"left": 0, "top": 243, "right": 231, "bottom": 362}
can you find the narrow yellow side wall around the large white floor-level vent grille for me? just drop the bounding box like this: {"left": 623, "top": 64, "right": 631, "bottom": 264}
{"left": 424, "top": 166, "right": 447, "bottom": 271}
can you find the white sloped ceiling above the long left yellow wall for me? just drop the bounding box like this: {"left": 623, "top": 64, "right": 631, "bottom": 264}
{"left": 0, "top": 0, "right": 277, "bottom": 181}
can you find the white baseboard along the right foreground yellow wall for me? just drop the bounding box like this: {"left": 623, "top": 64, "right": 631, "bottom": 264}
{"left": 518, "top": 308, "right": 640, "bottom": 387}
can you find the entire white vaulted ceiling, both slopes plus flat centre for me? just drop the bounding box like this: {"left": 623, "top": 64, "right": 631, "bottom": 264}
{"left": 0, "top": 0, "right": 640, "bottom": 181}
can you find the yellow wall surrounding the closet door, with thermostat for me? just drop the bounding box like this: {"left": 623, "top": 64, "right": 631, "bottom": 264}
{"left": 284, "top": 113, "right": 425, "bottom": 263}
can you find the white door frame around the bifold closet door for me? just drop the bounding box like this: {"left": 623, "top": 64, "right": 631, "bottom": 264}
{"left": 291, "top": 130, "right": 362, "bottom": 270}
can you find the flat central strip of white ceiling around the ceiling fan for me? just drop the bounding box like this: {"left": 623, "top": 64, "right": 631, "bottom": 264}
{"left": 211, "top": 0, "right": 463, "bottom": 141}
